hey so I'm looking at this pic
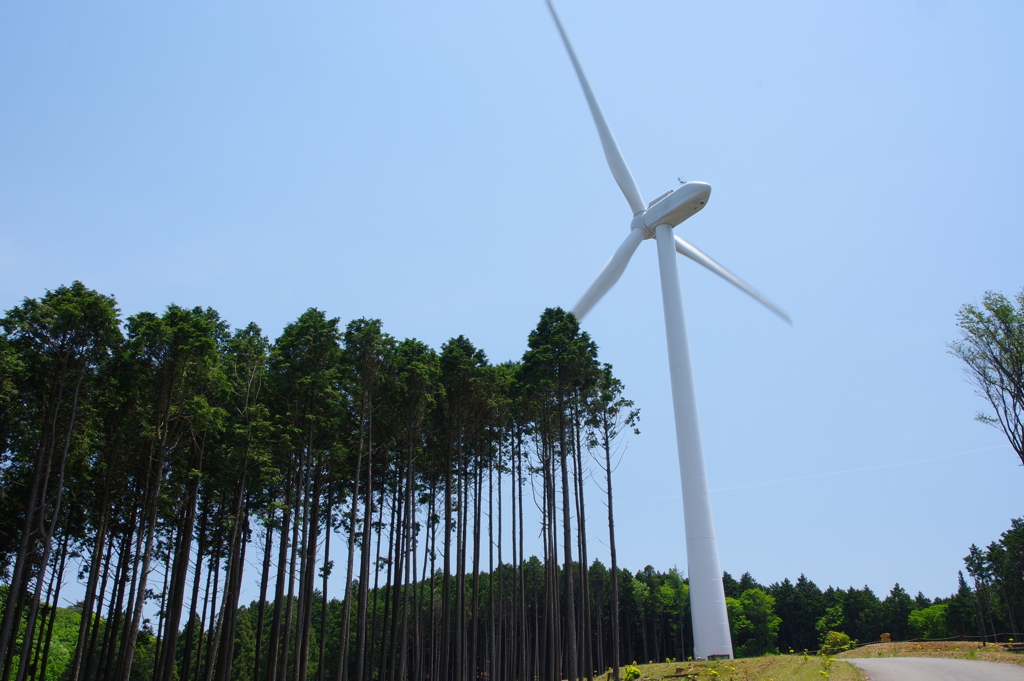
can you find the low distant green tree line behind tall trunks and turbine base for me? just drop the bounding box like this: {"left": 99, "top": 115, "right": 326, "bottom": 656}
{"left": 0, "top": 540, "right": 1024, "bottom": 681}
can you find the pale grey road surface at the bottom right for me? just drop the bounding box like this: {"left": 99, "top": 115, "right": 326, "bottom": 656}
{"left": 843, "top": 657, "right": 1024, "bottom": 681}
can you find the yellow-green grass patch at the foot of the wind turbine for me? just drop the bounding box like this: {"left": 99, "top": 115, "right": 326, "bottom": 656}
{"left": 599, "top": 655, "right": 865, "bottom": 681}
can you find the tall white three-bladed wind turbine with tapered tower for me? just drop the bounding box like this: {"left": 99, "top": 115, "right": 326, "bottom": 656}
{"left": 546, "top": 0, "right": 792, "bottom": 659}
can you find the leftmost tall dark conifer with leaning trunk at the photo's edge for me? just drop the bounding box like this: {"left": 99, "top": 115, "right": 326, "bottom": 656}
{"left": 0, "top": 282, "right": 120, "bottom": 678}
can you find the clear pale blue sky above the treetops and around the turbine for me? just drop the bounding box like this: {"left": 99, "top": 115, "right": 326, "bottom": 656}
{"left": 0, "top": 0, "right": 1024, "bottom": 596}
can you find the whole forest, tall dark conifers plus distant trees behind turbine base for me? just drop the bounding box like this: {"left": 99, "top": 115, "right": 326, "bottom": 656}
{"left": 0, "top": 282, "right": 1024, "bottom": 681}
